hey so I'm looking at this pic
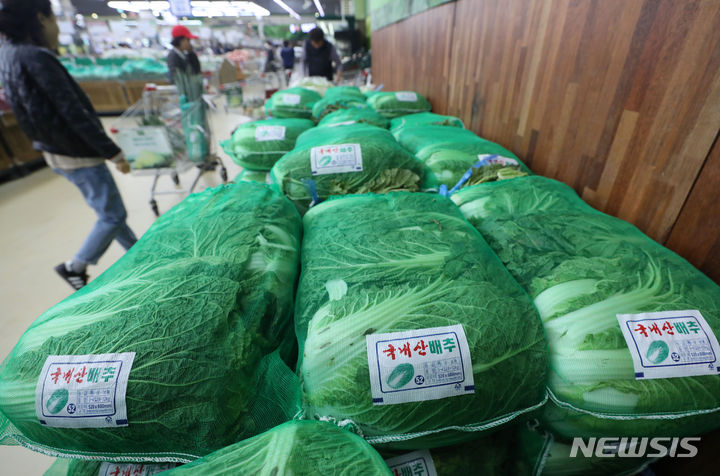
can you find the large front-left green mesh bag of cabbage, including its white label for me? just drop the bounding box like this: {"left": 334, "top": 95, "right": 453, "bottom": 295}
{"left": 0, "top": 182, "right": 301, "bottom": 461}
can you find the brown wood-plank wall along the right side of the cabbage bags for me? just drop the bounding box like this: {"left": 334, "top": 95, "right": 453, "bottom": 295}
{"left": 373, "top": 0, "right": 720, "bottom": 279}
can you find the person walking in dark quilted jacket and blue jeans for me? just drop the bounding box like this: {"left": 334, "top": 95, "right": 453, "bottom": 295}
{"left": 0, "top": 0, "right": 137, "bottom": 290}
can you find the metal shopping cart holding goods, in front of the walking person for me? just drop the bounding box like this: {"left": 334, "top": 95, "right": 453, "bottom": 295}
{"left": 111, "top": 83, "right": 227, "bottom": 216}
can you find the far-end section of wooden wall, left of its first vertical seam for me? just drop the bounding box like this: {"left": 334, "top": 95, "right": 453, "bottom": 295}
{"left": 372, "top": 2, "right": 455, "bottom": 113}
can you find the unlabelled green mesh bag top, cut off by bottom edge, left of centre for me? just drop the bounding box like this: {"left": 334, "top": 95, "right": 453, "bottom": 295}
{"left": 163, "top": 420, "right": 392, "bottom": 476}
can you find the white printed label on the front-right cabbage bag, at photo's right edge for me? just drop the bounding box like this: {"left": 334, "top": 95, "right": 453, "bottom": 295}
{"left": 617, "top": 310, "right": 720, "bottom": 379}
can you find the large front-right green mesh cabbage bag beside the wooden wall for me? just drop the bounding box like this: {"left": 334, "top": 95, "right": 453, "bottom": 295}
{"left": 452, "top": 176, "right": 720, "bottom": 438}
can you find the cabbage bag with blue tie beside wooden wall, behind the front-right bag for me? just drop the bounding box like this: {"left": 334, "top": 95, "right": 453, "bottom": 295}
{"left": 392, "top": 124, "right": 530, "bottom": 188}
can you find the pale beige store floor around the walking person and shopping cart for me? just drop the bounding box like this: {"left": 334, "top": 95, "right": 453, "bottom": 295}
{"left": 0, "top": 104, "right": 248, "bottom": 476}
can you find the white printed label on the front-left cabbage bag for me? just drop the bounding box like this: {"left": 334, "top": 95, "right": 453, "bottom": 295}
{"left": 35, "top": 352, "right": 135, "bottom": 428}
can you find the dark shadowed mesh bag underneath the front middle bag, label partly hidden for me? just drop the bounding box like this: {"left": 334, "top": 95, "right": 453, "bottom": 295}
{"left": 380, "top": 424, "right": 552, "bottom": 476}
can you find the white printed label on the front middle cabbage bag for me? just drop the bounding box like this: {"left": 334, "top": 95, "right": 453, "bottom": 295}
{"left": 366, "top": 324, "right": 475, "bottom": 405}
